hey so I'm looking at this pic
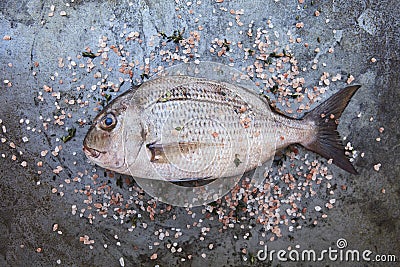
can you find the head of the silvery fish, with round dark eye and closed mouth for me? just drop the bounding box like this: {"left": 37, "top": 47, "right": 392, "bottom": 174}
{"left": 83, "top": 91, "right": 136, "bottom": 173}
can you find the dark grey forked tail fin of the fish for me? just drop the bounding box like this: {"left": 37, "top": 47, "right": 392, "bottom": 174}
{"left": 301, "top": 85, "right": 361, "bottom": 174}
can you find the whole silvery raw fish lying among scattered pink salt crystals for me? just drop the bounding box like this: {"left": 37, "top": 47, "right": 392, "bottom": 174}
{"left": 83, "top": 75, "right": 360, "bottom": 181}
